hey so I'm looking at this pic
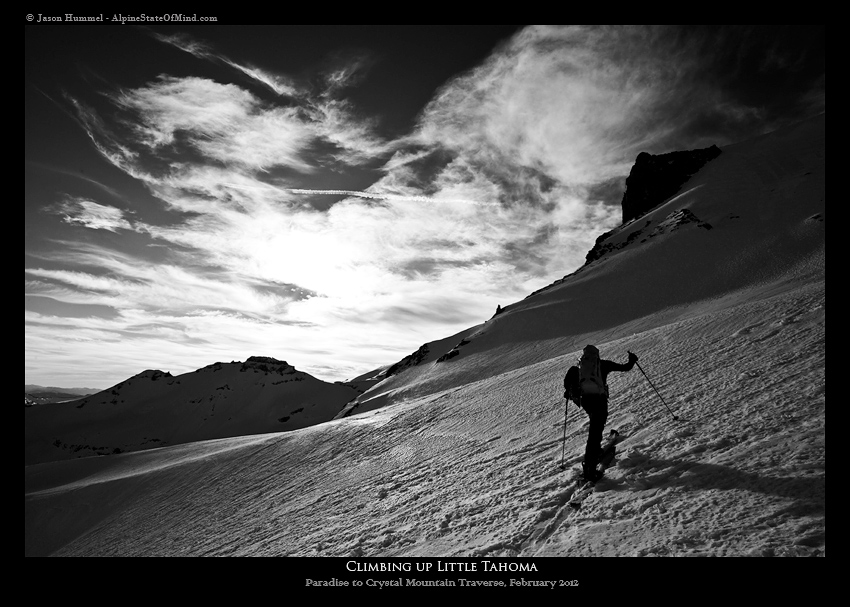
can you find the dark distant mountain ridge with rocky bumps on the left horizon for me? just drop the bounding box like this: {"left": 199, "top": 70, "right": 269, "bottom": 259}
{"left": 24, "top": 356, "right": 358, "bottom": 465}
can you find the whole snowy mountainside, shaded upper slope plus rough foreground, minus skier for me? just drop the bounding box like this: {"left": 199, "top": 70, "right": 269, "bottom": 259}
{"left": 25, "top": 115, "right": 826, "bottom": 560}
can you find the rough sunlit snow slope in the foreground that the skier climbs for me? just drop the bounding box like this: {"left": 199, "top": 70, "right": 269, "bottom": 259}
{"left": 46, "top": 282, "right": 825, "bottom": 557}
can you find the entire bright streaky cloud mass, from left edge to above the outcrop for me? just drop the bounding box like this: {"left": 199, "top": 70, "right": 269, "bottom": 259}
{"left": 27, "top": 26, "right": 822, "bottom": 379}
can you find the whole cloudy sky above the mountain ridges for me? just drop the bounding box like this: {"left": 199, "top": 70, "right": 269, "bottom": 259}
{"left": 24, "top": 22, "right": 825, "bottom": 388}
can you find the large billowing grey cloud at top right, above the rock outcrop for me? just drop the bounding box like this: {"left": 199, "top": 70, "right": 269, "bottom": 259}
{"left": 400, "top": 26, "right": 824, "bottom": 200}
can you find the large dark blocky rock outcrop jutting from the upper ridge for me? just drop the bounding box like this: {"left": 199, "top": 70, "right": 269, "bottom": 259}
{"left": 622, "top": 145, "right": 720, "bottom": 223}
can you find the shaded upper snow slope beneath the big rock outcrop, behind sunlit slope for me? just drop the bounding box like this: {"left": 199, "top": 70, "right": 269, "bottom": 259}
{"left": 338, "top": 116, "right": 825, "bottom": 422}
